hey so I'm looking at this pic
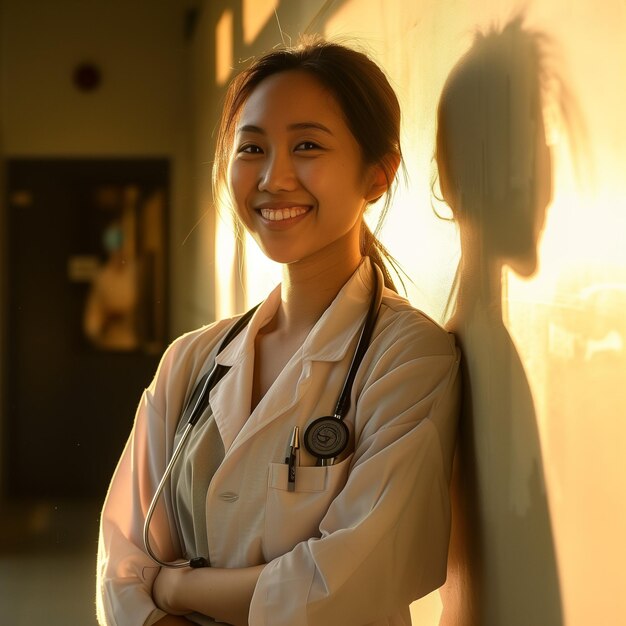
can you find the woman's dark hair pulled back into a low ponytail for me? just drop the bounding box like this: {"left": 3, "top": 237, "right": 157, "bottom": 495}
{"left": 213, "top": 39, "right": 402, "bottom": 290}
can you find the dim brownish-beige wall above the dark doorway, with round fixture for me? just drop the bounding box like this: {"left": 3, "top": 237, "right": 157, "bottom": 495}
{"left": 2, "top": 0, "right": 184, "bottom": 156}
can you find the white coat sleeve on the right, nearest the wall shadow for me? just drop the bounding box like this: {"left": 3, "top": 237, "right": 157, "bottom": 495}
{"left": 249, "top": 316, "right": 459, "bottom": 626}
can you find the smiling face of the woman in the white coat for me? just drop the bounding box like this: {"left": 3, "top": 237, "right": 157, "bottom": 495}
{"left": 229, "top": 71, "right": 380, "bottom": 263}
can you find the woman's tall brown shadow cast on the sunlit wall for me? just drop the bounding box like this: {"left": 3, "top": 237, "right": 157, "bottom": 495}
{"left": 436, "top": 17, "right": 567, "bottom": 626}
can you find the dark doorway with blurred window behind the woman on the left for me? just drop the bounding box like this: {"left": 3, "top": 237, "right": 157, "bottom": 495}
{"left": 2, "top": 159, "right": 169, "bottom": 499}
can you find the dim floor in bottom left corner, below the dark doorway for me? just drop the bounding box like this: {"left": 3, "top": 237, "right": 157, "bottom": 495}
{"left": 0, "top": 502, "right": 100, "bottom": 626}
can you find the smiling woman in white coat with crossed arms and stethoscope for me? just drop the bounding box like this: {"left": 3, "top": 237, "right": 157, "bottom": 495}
{"left": 98, "top": 41, "right": 459, "bottom": 626}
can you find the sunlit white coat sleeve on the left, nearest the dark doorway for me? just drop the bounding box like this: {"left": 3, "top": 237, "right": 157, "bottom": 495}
{"left": 96, "top": 322, "right": 224, "bottom": 626}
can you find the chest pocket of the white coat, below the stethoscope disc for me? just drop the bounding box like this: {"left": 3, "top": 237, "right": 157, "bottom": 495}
{"left": 263, "top": 454, "right": 352, "bottom": 562}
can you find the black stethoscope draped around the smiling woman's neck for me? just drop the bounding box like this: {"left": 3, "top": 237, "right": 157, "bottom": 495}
{"left": 143, "top": 263, "right": 383, "bottom": 568}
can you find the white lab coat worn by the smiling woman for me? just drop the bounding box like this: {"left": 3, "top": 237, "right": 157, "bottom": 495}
{"left": 97, "top": 262, "right": 459, "bottom": 626}
